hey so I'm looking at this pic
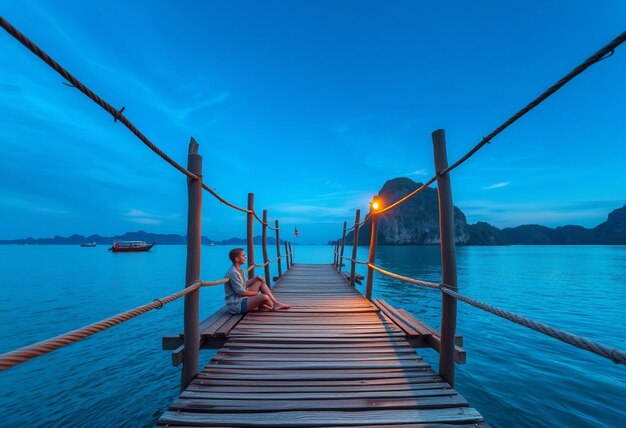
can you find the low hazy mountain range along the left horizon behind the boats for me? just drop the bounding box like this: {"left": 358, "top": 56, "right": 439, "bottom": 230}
{"left": 0, "top": 230, "right": 284, "bottom": 245}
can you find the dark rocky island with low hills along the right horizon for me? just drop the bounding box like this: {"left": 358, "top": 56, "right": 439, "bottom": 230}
{"left": 342, "top": 178, "right": 626, "bottom": 245}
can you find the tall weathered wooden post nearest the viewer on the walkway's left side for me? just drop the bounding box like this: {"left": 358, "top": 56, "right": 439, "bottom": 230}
{"left": 180, "top": 137, "right": 202, "bottom": 391}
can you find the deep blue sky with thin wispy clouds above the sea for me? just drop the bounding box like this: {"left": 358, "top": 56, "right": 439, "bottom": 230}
{"left": 0, "top": 0, "right": 626, "bottom": 243}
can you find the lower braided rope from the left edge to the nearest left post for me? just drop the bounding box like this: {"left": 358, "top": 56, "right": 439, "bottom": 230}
{"left": 0, "top": 281, "right": 202, "bottom": 371}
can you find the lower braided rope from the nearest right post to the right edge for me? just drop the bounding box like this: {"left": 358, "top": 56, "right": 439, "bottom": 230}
{"left": 439, "top": 284, "right": 626, "bottom": 365}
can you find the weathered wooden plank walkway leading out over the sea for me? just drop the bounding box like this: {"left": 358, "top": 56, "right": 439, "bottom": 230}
{"left": 158, "top": 264, "right": 488, "bottom": 428}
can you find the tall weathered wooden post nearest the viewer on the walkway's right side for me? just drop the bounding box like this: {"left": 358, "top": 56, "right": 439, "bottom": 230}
{"left": 432, "top": 129, "right": 457, "bottom": 387}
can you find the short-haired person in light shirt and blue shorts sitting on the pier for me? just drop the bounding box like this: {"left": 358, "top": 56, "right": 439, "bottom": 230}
{"left": 224, "top": 248, "right": 291, "bottom": 314}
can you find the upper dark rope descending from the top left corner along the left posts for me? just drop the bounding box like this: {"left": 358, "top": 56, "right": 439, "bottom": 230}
{"left": 0, "top": 16, "right": 276, "bottom": 230}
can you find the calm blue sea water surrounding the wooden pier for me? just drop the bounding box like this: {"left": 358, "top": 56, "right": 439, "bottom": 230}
{"left": 0, "top": 242, "right": 626, "bottom": 427}
